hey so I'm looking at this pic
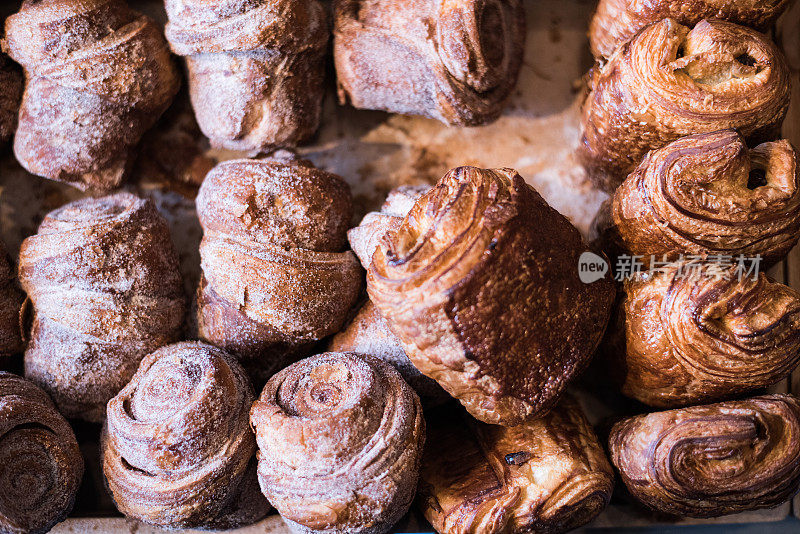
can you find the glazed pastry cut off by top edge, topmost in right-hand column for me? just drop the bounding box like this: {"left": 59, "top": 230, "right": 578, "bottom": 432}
{"left": 589, "top": 0, "right": 790, "bottom": 57}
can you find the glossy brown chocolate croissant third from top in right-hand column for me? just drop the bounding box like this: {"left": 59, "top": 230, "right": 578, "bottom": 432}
{"left": 598, "top": 130, "right": 800, "bottom": 264}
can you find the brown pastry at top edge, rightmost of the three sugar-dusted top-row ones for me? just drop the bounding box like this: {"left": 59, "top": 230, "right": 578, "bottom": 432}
{"left": 333, "top": 0, "right": 525, "bottom": 126}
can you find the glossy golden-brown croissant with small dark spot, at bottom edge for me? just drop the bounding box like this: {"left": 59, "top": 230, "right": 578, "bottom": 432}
{"left": 419, "top": 395, "right": 614, "bottom": 534}
